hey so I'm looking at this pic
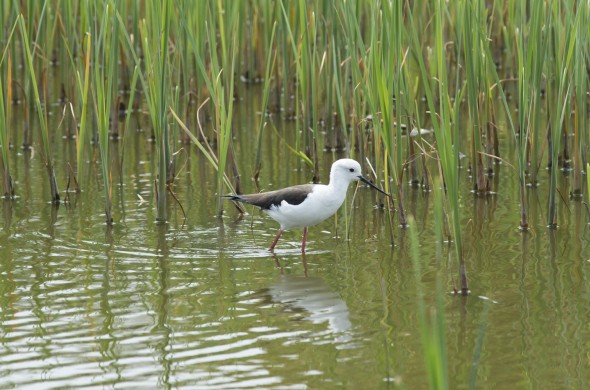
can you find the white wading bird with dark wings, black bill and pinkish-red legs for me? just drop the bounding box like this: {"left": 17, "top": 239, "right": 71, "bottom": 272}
{"left": 225, "top": 158, "right": 390, "bottom": 253}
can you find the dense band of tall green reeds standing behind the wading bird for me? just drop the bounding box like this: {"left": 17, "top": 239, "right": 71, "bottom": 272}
{"left": 0, "top": 0, "right": 590, "bottom": 272}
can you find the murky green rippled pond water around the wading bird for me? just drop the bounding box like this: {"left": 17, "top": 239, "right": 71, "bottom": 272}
{"left": 0, "top": 84, "right": 590, "bottom": 389}
